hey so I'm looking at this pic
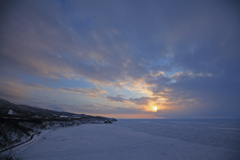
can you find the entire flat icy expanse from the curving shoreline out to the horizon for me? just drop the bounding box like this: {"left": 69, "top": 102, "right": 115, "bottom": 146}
{"left": 15, "top": 120, "right": 240, "bottom": 160}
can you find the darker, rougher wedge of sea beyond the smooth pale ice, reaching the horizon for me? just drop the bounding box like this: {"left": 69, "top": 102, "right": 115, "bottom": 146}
{"left": 119, "top": 119, "right": 240, "bottom": 152}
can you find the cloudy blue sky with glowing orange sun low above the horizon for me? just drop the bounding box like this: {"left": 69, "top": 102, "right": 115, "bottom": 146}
{"left": 0, "top": 0, "right": 240, "bottom": 119}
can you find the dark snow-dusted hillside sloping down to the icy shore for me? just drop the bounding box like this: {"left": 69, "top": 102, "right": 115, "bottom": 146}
{"left": 0, "top": 99, "right": 117, "bottom": 150}
